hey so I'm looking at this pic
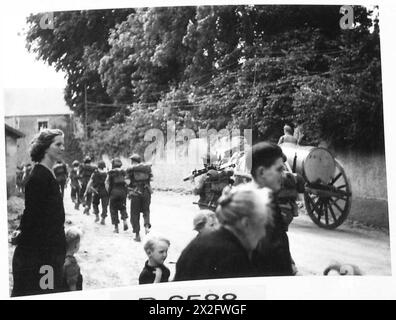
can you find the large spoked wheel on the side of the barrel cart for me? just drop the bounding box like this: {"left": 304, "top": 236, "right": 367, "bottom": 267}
{"left": 304, "top": 160, "right": 352, "bottom": 229}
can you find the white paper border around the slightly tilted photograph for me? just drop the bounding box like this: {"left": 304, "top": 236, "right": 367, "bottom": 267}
{"left": 0, "top": 0, "right": 396, "bottom": 300}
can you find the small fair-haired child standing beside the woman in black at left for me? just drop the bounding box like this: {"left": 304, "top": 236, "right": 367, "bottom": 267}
{"left": 63, "top": 227, "right": 83, "bottom": 291}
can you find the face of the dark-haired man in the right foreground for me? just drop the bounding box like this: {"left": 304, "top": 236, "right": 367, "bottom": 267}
{"left": 254, "top": 157, "right": 284, "bottom": 192}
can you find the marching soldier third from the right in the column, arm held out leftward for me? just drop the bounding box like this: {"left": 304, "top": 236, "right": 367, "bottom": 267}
{"left": 85, "top": 160, "right": 109, "bottom": 224}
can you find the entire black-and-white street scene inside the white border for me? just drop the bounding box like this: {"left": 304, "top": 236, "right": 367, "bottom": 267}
{"left": 2, "top": 2, "right": 392, "bottom": 299}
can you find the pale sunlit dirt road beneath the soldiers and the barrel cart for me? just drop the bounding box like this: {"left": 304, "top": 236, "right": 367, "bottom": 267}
{"left": 10, "top": 190, "right": 391, "bottom": 296}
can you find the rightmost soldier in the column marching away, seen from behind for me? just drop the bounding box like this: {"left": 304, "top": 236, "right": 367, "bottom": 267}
{"left": 127, "top": 155, "right": 153, "bottom": 241}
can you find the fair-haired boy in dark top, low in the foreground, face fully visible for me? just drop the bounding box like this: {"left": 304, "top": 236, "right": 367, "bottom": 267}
{"left": 139, "top": 237, "right": 170, "bottom": 284}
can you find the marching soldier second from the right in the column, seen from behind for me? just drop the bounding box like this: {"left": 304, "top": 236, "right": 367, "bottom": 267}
{"left": 105, "top": 158, "right": 128, "bottom": 233}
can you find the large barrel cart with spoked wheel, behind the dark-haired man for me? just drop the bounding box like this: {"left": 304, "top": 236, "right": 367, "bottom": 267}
{"left": 234, "top": 143, "right": 352, "bottom": 229}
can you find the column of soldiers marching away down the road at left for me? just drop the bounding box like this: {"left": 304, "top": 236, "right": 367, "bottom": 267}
{"left": 69, "top": 154, "right": 153, "bottom": 241}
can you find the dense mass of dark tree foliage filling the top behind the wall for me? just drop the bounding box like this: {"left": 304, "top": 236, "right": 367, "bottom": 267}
{"left": 27, "top": 5, "right": 384, "bottom": 153}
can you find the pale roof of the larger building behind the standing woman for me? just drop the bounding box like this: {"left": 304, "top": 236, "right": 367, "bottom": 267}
{"left": 3, "top": 88, "right": 73, "bottom": 117}
